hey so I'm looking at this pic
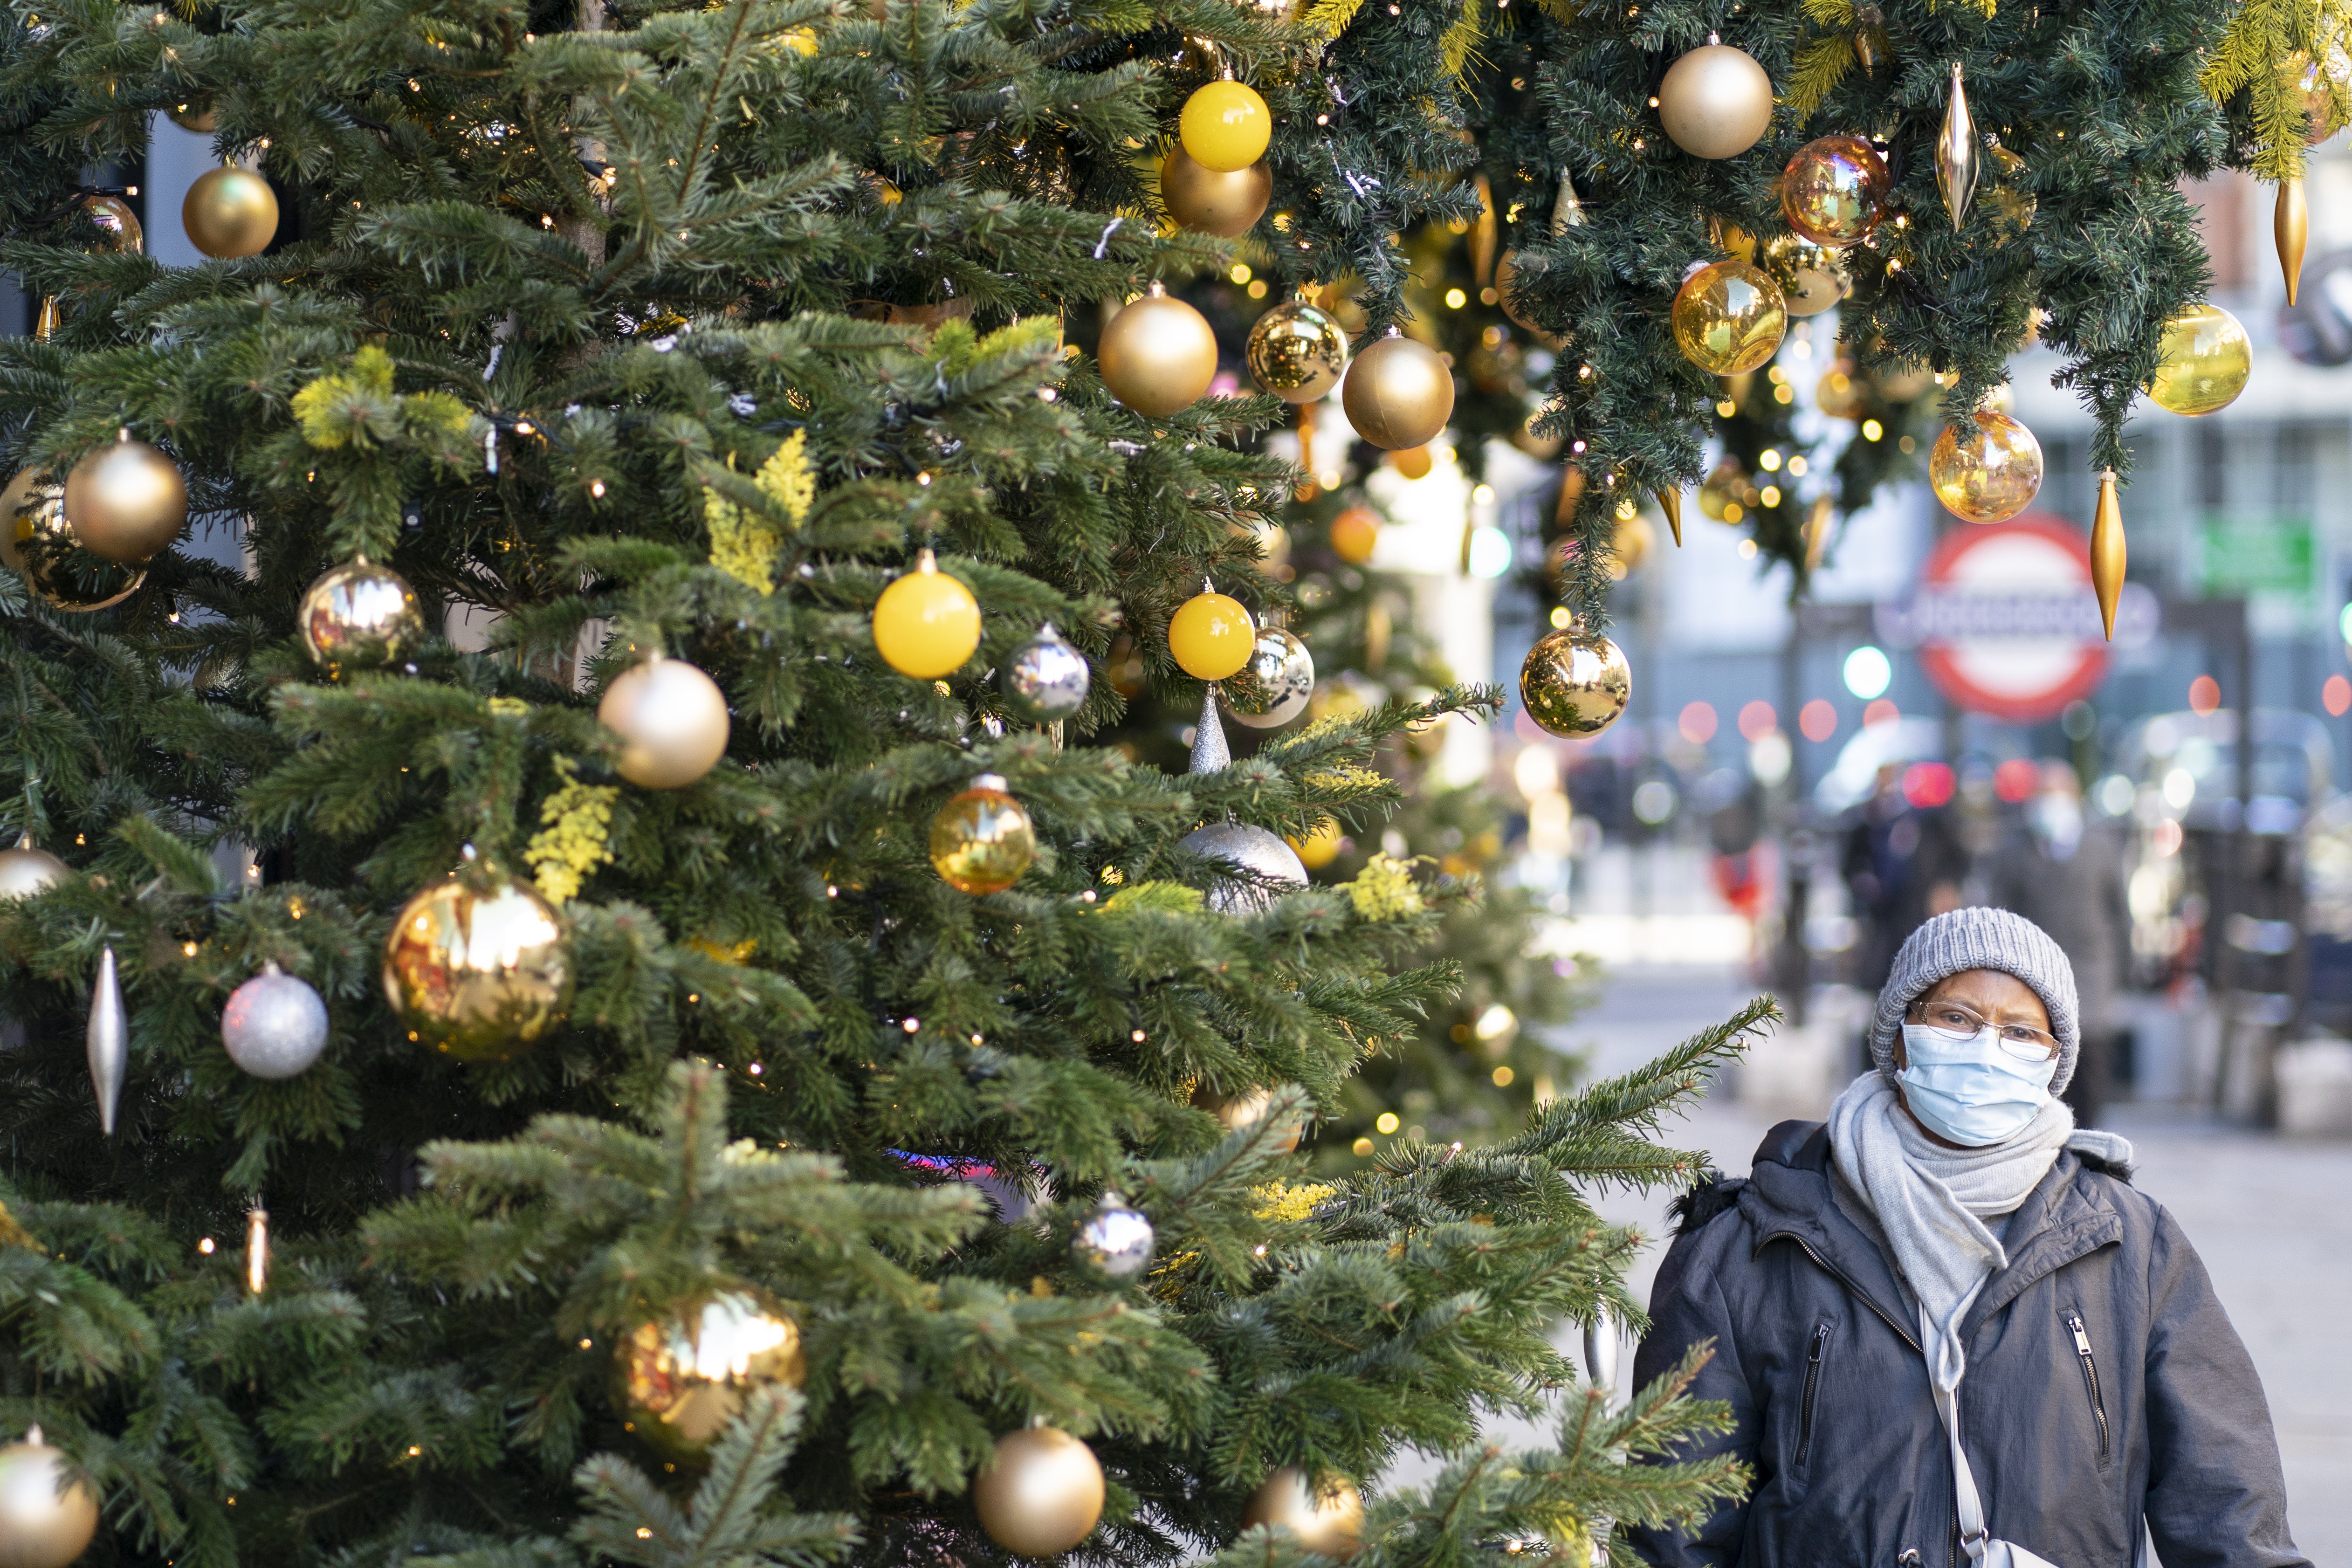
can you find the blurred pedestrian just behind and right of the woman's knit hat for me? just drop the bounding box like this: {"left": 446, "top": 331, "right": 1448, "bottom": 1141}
{"left": 1988, "top": 759, "right": 2131, "bottom": 1126}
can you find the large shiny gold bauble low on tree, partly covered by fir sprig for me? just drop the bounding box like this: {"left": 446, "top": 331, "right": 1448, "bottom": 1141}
{"left": 612, "top": 1284, "right": 809, "bottom": 1462}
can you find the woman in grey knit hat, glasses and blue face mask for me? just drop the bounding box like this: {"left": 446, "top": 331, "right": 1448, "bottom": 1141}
{"left": 1630, "top": 908, "right": 2310, "bottom": 1568}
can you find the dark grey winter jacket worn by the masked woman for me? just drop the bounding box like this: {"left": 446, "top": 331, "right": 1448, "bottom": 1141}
{"left": 1630, "top": 1121, "right": 2310, "bottom": 1568}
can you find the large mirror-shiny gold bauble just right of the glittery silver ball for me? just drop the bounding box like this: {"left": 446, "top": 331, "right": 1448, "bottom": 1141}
{"left": 383, "top": 872, "right": 571, "bottom": 1063}
